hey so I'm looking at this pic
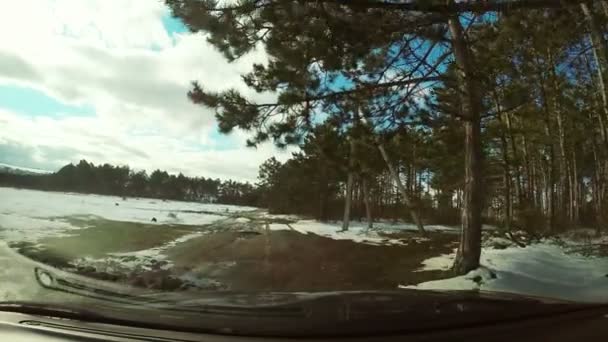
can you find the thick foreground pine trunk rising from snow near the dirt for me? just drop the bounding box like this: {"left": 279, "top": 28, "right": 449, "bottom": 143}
{"left": 448, "top": 15, "right": 483, "bottom": 274}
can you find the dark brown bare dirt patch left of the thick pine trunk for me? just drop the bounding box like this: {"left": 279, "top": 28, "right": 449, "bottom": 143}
{"left": 166, "top": 231, "right": 457, "bottom": 291}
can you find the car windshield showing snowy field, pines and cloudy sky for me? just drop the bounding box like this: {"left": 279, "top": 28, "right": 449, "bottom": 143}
{"left": 0, "top": 0, "right": 608, "bottom": 336}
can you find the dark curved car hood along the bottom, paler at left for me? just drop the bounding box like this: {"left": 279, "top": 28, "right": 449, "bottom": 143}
{"left": 0, "top": 245, "right": 598, "bottom": 336}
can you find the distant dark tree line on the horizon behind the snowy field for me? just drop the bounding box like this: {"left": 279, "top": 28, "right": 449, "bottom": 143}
{"left": 0, "top": 160, "right": 259, "bottom": 206}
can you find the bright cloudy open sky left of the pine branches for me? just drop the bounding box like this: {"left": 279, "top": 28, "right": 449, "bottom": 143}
{"left": 0, "top": 0, "right": 291, "bottom": 181}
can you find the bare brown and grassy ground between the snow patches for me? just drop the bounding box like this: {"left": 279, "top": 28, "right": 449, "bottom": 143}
{"left": 11, "top": 212, "right": 458, "bottom": 291}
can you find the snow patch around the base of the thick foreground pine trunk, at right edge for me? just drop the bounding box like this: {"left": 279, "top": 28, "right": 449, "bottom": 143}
{"left": 400, "top": 241, "right": 608, "bottom": 302}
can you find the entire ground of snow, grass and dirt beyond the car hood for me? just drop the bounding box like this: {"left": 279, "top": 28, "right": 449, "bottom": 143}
{"left": 0, "top": 188, "right": 608, "bottom": 301}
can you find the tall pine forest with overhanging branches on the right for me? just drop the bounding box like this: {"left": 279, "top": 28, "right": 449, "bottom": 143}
{"left": 165, "top": 0, "right": 608, "bottom": 273}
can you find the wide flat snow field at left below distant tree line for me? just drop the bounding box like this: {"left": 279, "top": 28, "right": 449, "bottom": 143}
{"left": 0, "top": 187, "right": 256, "bottom": 240}
